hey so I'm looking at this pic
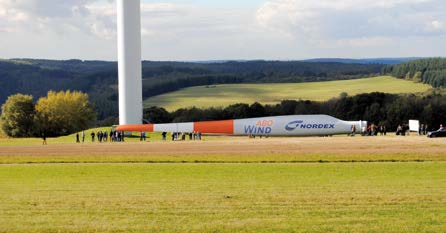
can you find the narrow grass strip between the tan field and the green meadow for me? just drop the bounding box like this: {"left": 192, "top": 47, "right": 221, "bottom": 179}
{"left": 0, "top": 153, "right": 446, "bottom": 164}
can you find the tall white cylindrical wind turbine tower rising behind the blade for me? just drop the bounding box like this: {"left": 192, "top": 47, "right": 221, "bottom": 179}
{"left": 117, "top": 0, "right": 143, "bottom": 125}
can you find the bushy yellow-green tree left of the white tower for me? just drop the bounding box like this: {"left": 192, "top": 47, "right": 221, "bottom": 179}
{"left": 36, "top": 91, "right": 96, "bottom": 136}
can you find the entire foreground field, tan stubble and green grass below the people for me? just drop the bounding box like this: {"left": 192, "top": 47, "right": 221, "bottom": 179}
{"left": 0, "top": 137, "right": 446, "bottom": 232}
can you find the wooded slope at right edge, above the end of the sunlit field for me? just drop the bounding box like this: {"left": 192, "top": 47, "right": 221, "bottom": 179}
{"left": 383, "top": 58, "right": 446, "bottom": 87}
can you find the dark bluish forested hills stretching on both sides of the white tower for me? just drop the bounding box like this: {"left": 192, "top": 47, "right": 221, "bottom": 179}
{"left": 0, "top": 59, "right": 383, "bottom": 119}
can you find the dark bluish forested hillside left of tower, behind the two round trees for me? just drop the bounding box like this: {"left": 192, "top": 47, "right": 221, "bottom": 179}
{"left": 0, "top": 59, "right": 118, "bottom": 119}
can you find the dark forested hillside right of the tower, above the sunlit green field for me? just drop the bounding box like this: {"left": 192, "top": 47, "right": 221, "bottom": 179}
{"left": 143, "top": 61, "right": 383, "bottom": 98}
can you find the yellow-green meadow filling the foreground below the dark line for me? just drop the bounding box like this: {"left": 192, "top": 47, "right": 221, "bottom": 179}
{"left": 0, "top": 162, "right": 446, "bottom": 232}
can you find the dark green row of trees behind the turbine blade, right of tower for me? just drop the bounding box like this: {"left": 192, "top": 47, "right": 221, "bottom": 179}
{"left": 144, "top": 92, "right": 446, "bottom": 130}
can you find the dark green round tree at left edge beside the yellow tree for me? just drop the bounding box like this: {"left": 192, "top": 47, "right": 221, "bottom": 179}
{"left": 0, "top": 94, "right": 35, "bottom": 137}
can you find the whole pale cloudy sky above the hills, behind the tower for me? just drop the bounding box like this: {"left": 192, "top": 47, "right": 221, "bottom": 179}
{"left": 0, "top": 0, "right": 446, "bottom": 61}
